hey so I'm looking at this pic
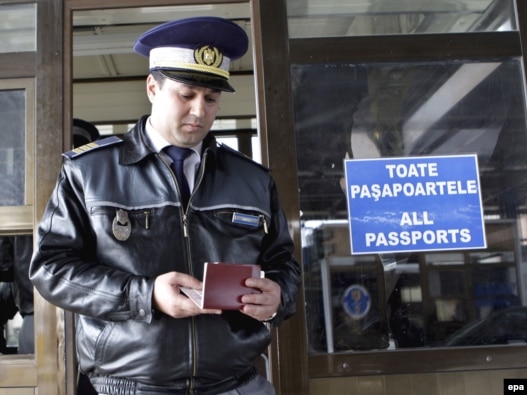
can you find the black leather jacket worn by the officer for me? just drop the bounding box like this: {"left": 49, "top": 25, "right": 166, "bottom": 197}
{"left": 30, "top": 117, "right": 300, "bottom": 394}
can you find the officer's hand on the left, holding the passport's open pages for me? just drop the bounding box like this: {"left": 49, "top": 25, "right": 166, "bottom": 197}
{"left": 152, "top": 272, "right": 221, "bottom": 318}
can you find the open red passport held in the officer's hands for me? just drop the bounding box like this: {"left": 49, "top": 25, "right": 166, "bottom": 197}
{"left": 181, "top": 262, "right": 264, "bottom": 310}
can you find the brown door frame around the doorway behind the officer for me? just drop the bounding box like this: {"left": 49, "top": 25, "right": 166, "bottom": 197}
{"left": 61, "top": 0, "right": 308, "bottom": 395}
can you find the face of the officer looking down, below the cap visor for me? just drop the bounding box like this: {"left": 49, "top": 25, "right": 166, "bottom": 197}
{"left": 146, "top": 75, "right": 221, "bottom": 147}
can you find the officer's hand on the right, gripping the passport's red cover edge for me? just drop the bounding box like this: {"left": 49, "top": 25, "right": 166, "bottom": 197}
{"left": 241, "top": 278, "right": 281, "bottom": 321}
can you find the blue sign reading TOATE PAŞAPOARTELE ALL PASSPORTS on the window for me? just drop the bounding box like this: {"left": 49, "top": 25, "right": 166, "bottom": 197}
{"left": 344, "top": 155, "right": 487, "bottom": 254}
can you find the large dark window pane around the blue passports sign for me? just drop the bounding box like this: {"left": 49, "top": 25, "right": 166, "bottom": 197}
{"left": 292, "top": 59, "right": 527, "bottom": 353}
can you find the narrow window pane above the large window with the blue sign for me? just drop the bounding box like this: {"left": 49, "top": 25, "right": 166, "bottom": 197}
{"left": 287, "top": 0, "right": 517, "bottom": 38}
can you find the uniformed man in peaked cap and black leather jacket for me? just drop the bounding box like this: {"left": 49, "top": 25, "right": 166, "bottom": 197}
{"left": 30, "top": 17, "right": 300, "bottom": 395}
